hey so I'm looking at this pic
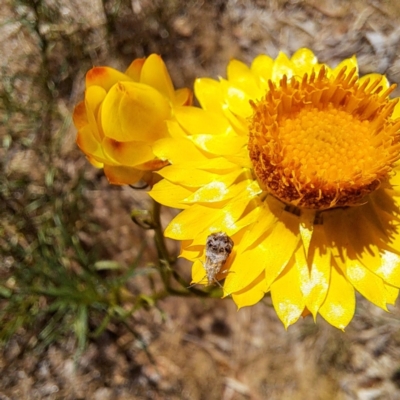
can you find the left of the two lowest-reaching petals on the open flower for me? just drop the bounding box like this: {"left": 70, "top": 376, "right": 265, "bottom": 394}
{"left": 271, "top": 260, "right": 305, "bottom": 329}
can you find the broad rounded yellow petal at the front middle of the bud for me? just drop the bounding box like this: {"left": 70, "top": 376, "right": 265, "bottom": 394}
{"left": 101, "top": 82, "right": 171, "bottom": 143}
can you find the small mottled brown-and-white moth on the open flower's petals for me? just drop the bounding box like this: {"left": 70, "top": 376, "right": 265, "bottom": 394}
{"left": 203, "top": 232, "right": 234, "bottom": 286}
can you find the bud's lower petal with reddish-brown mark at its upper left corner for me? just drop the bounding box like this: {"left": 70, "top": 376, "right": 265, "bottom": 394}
{"left": 102, "top": 138, "right": 154, "bottom": 167}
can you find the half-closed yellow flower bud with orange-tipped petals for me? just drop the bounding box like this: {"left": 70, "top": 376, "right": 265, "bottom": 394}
{"left": 73, "top": 54, "right": 192, "bottom": 185}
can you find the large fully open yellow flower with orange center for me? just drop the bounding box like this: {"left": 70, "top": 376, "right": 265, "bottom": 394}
{"left": 150, "top": 49, "right": 400, "bottom": 329}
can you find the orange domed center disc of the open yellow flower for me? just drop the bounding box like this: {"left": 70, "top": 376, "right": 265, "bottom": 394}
{"left": 249, "top": 68, "right": 400, "bottom": 210}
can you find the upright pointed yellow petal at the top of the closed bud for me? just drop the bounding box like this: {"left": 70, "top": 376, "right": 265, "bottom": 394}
{"left": 140, "top": 54, "right": 175, "bottom": 100}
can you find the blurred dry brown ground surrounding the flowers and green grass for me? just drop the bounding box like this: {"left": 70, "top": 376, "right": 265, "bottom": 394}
{"left": 0, "top": 0, "right": 400, "bottom": 400}
